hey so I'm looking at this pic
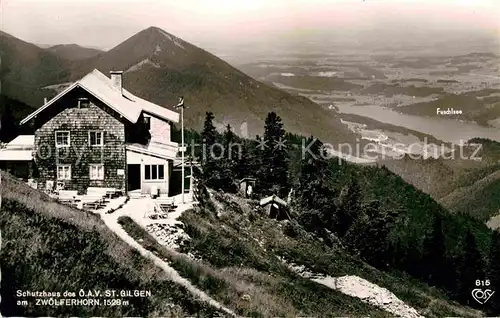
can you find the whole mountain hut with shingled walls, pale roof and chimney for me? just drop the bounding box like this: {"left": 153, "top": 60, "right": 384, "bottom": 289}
{"left": 8, "top": 70, "right": 179, "bottom": 195}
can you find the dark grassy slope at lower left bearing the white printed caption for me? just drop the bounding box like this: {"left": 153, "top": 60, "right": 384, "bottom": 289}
{"left": 0, "top": 176, "right": 221, "bottom": 317}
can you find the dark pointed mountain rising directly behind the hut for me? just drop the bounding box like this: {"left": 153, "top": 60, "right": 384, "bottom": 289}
{"left": 0, "top": 27, "right": 355, "bottom": 143}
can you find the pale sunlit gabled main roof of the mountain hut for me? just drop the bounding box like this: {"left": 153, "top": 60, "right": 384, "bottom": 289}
{"left": 21, "top": 69, "right": 179, "bottom": 125}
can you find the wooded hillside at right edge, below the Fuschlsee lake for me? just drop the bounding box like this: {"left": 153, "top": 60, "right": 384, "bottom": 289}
{"left": 383, "top": 138, "right": 500, "bottom": 222}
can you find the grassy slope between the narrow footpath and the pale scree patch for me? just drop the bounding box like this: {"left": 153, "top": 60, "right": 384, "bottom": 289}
{"left": 119, "top": 210, "right": 389, "bottom": 317}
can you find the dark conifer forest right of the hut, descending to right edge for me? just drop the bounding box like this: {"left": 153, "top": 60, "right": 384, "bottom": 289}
{"left": 175, "top": 112, "right": 500, "bottom": 314}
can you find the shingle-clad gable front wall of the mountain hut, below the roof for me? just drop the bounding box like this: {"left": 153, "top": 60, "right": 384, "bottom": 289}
{"left": 34, "top": 89, "right": 127, "bottom": 193}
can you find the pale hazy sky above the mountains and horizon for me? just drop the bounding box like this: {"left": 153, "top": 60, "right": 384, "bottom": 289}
{"left": 0, "top": 0, "right": 500, "bottom": 49}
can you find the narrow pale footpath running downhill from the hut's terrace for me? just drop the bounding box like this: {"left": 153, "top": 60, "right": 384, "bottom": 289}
{"left": 101, "top": 200, "right": 236, "bottom": 317}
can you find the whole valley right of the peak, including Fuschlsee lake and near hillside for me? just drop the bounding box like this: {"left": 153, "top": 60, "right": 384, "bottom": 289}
{"left": 237, "top": 45, "right": 500, "bottom": 227}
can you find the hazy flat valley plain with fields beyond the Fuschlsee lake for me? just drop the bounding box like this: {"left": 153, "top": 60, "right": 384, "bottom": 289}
{"left": 238, "top": 49, "right": 500, "bottom": 136}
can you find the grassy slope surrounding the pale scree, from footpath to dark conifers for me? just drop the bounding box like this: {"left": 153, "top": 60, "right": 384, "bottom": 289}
{"left": 122, "top": 194, "right": 480, "bottom": 317}
